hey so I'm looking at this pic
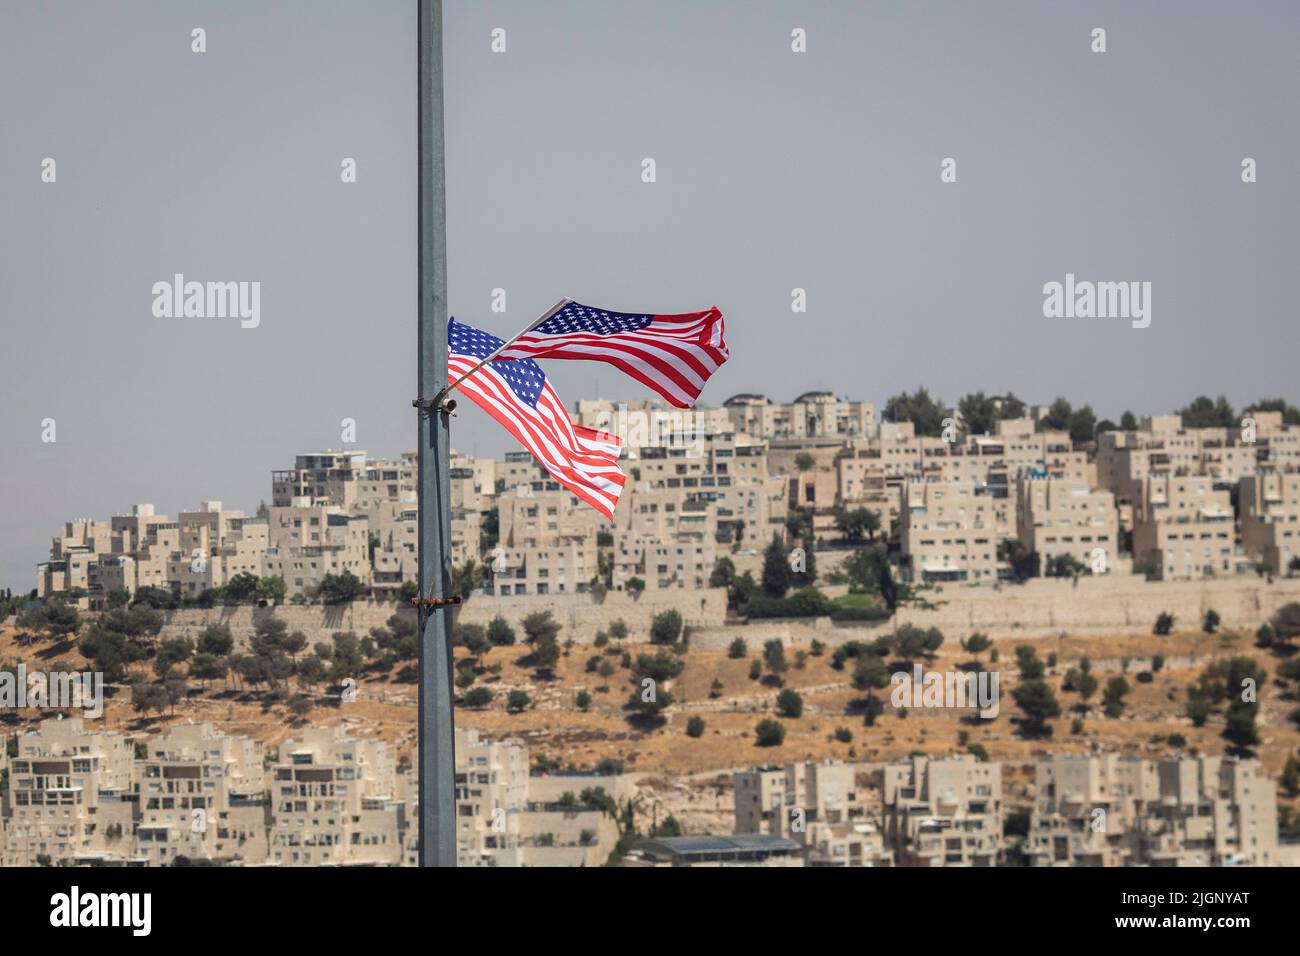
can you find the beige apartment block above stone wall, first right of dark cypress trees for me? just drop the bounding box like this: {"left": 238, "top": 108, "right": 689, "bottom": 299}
{"left": 898, "top": 481, "right": 1005, "bottom": 584}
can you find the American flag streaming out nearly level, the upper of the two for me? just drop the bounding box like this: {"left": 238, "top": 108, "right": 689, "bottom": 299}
{"left": 501, "top": 302, "right": 729, "bottom": 408}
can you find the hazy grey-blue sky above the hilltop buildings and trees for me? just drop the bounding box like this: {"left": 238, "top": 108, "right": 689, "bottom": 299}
{"left": 0, "top": 0, "right": 1300, "bottom": 589}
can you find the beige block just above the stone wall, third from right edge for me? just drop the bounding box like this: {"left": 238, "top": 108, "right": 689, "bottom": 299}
{"left": 1017, "top": 476, "right": 1119, "bottom": 574}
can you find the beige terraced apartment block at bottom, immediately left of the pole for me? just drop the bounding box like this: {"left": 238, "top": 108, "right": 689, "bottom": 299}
{"left": 269, "top": 727, "right": 407, "bottom": 866}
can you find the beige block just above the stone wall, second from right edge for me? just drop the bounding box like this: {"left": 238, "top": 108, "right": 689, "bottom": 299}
{"left": 1132, "top": 475, "right": 1235, "bottom": 580}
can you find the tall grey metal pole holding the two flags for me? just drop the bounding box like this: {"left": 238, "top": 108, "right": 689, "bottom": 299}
{"left": 413, "top": 0, "right": 456, "bottom": 866}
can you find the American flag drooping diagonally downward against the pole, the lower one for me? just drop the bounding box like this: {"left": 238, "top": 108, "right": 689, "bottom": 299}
{"left": 447, "top": 319, "right": 624, "bottom": 520}
